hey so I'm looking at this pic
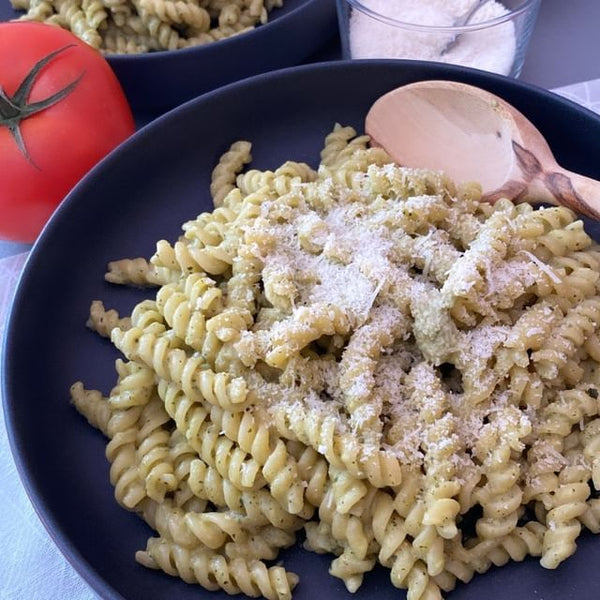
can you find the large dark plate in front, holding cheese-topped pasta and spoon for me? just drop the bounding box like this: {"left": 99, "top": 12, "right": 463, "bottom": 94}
{"left": 2, "top": 61, "right": 600, "bottom": 600}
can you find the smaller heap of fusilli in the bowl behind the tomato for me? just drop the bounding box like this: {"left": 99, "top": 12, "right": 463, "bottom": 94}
{"left": 11, "top": 0, "right": 283, "bottom": 54}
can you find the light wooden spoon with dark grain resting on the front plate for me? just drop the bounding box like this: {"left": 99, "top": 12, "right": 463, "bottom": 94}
{"left": 365, "top": 81, "right": 600, "bottom": 219}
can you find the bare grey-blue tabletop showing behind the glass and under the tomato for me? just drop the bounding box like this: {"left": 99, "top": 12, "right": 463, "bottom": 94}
{"left": 0, "top": 0, "right": 600, "bottom": 259}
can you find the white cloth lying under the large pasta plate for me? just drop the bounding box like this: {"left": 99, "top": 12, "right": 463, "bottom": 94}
{"left": 0, "top": 79, "right": 600, "bottom": 600}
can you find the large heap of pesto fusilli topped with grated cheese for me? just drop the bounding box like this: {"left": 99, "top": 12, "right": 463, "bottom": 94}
{"left": 72, "top": 125, "right": 600, "bottom": 600}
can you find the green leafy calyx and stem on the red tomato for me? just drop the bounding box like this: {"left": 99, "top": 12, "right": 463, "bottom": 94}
{"left": 0, "top": 44, "right": 83, "bottom": 166}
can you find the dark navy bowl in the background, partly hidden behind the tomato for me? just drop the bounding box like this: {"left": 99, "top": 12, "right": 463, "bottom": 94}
{"left": 0, "top": 0, "right": 337, "bottom": 116}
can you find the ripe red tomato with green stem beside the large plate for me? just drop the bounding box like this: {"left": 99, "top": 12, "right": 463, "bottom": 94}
{"left": 0, "top": 22, "right": 134, "bottom": 242}
